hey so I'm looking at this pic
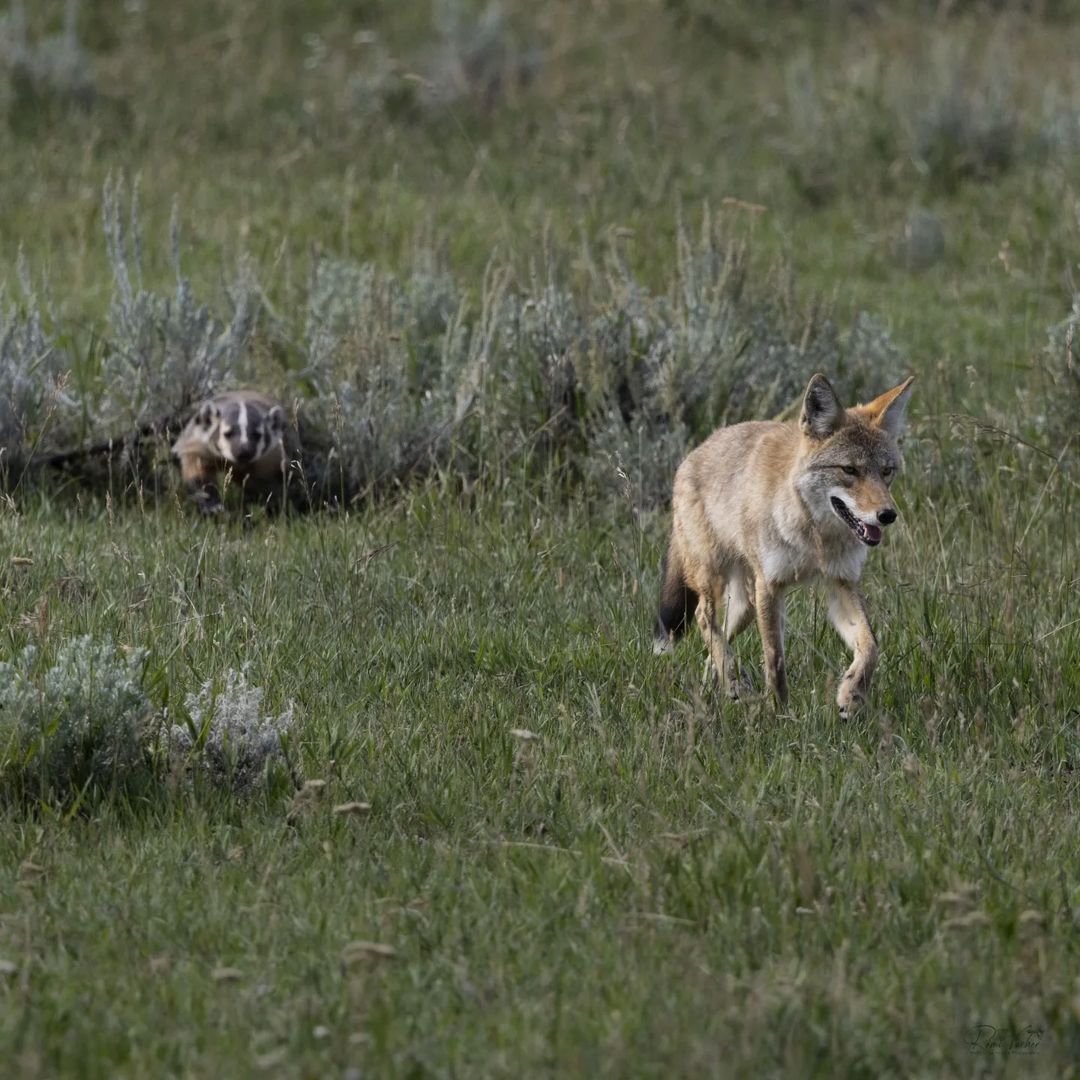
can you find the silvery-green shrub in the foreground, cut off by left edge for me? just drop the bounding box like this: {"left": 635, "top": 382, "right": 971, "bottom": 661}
{"left": 0, "top": 636, "right": 152, "bottom": 804}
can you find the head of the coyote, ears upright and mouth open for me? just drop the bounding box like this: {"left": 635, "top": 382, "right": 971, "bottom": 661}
{"left": 795, "top": 375, "right": 915, "bottom": 548}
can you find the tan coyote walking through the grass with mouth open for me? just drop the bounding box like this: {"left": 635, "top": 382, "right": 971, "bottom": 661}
{"left": 657, "top": 375, "right": 914, "bottom": 718}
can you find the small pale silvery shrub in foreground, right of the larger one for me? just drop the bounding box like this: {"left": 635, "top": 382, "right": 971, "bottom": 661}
{"left": 168, "top": 669, "right": 295, "bottom": 795}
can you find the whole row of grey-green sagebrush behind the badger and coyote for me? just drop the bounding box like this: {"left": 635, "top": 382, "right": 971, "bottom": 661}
{"left": 0, "top": 184, "right": 904, "bottom": 509}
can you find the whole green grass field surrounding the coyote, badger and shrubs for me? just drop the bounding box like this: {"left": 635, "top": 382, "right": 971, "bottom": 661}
{"left": 0, "top": 0, "right": 1080, "bottom": 1077}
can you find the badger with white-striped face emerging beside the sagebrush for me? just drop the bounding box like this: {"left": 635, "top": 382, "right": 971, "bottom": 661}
{"left": 173, "top": 390, "right": 293, "bottom": 514}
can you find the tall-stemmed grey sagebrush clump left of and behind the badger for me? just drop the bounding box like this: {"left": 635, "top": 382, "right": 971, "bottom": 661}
{"left": 0, "top": 178, "right": 261, "bottom": 487}
